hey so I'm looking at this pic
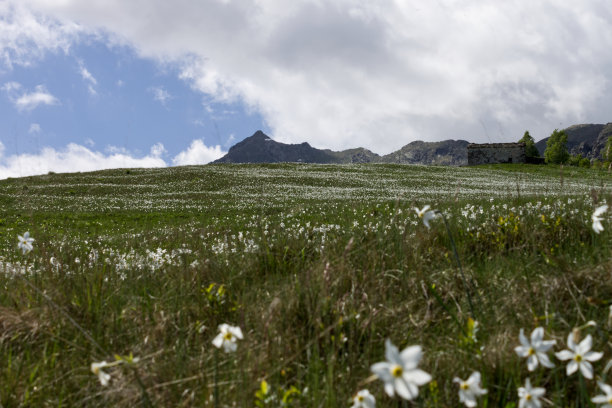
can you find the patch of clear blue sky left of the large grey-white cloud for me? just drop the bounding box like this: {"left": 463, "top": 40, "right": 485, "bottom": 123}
{"left": 0, "top": 41, "right": 267, "bottom": 171}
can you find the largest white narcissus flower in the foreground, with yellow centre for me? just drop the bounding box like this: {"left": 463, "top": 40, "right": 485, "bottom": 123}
{"left": 370, "top": 339, "right": 431, "bottom": 400}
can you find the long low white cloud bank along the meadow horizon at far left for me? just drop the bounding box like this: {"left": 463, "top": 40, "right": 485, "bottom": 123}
{"left": 0, "top": 143, "right": 166, "bottom": 179}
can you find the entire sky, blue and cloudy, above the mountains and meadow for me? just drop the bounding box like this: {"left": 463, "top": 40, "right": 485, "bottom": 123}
{"left": 0, "top": 0, "right": 612, "bottom": 178}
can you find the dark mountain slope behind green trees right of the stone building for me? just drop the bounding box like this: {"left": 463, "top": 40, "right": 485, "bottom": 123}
{"left": 536, "top": 123, "right": 612, "bottom": 159}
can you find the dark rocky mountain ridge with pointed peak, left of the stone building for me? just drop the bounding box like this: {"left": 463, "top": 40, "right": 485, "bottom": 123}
{"left": 214, "top": 130, "right": 468, "bottom": 165}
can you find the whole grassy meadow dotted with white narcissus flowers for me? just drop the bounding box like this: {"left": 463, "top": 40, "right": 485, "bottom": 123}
{"left": 0, "top": 164, "right": 612, "bottom": 408}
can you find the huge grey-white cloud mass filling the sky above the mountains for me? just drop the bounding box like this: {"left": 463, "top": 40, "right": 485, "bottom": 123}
{"left": 7, "top": 0, "right": 612, "bottom": 153}
